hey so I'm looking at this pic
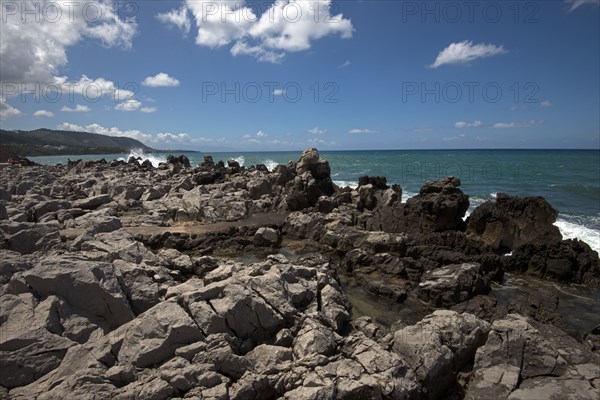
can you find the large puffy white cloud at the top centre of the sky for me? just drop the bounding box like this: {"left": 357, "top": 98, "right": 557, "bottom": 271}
{"left": 157, "top": 0, "right": 353, "bottom": 63}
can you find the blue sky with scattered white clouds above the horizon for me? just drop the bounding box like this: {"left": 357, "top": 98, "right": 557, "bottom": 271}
{"left": 0, "top": 0, "right": 600, "bottom": 151}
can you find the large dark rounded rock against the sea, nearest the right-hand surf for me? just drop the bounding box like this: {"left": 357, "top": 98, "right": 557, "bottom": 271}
{"left": 467, "top": 193, "right": 562, "bottom": 253}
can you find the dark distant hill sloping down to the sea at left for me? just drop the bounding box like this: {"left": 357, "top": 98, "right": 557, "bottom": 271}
{"left": 0, "top": 129, "right": 159, "bottom": 162}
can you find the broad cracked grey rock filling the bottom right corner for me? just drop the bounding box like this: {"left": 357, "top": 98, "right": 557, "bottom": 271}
{"left": 465, "top": 314, "right": 600, "bottom": 399}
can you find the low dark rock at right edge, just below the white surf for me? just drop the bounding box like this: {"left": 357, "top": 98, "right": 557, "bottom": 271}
{"left": 504, "top": 239, "right": 600, "bottom": 285}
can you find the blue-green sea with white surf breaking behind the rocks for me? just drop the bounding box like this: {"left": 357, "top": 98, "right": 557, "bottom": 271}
{"left": 30, "top": 150, "right": 600, "bottom": 254}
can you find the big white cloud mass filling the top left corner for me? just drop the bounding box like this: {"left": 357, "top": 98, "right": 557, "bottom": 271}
{"left": 0, "top": 0, "right": 137, "bottom": 83}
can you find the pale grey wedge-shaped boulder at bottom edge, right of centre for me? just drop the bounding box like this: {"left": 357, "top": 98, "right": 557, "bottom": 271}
{"left": 393, "top": 310, "right": 490, "bottom": 399}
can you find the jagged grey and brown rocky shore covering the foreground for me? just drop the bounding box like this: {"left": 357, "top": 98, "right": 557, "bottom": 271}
{"left": 0, "top": 149, "right": 600, "bottom": 400}
